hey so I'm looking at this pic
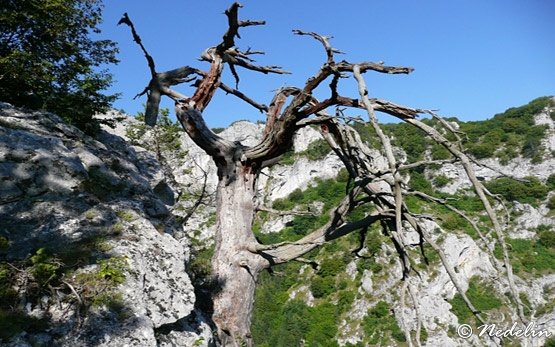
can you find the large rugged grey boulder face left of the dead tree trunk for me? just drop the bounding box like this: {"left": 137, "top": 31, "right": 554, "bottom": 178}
{"left": 0, "top": 104, "right": 210, "bottom": 346}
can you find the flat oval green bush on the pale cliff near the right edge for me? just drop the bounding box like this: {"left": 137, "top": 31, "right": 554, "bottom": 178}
{"left": 485, "top": 176, "right": 549, "bottom": 205}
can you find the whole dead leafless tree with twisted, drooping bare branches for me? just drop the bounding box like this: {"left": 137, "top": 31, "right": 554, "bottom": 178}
{"left": 120, "top": 3, "right": 525, "bottom": 346}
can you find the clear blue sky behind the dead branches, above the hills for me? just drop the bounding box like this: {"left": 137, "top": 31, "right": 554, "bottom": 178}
{"left": 97, "top": 0, "right": 555, "bottom": 127}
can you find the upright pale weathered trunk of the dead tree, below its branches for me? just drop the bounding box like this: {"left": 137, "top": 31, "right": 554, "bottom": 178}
{"left": 212, "top": 163, "right": 268, "bottom": 346}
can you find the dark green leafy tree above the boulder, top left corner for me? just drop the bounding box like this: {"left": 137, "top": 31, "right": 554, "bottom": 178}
{"left": 0, "top": 0, "right": 117, "bottom": 133}
